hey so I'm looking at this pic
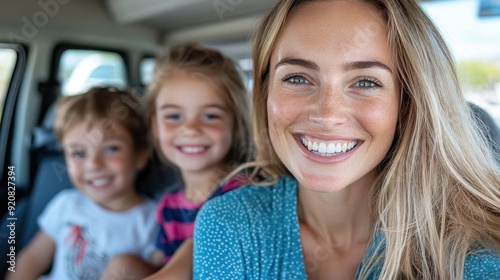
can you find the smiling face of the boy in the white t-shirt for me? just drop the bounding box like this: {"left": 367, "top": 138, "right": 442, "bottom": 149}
{"left": 62, "top": 122, "right": 147, "bottom": 211}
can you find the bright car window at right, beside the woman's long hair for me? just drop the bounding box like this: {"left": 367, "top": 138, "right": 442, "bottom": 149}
{"left": 422, "top": 0, "right": 500, "bottom": 127}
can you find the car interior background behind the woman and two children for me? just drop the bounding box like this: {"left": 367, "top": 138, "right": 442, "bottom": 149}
{"left": 0, "top": 0, "right": 500, "bottom": 278}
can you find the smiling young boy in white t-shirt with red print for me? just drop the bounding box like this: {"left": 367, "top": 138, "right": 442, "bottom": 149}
{"left": 8, "top": 88, "right": 156, "bottom": 280}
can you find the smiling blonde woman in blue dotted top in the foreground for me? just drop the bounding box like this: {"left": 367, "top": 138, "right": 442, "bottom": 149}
{"left": 194, "top": 0, "right": 500, "bottom": 279}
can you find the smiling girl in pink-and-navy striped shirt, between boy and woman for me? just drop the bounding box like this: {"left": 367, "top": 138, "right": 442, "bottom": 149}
{"left": 102, "top": 45, "right": 250, "bottom": 279}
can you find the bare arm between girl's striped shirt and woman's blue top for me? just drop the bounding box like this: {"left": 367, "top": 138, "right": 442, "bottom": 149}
{"left": 144, "top": 238, "right": 193, "bottom": 280}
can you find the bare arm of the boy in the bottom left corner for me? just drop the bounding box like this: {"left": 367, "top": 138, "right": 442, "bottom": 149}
{"left": 6, "top": 230, "right": 56, "bottom": 280}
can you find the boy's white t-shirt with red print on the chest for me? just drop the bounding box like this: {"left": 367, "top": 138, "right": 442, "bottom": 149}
{"left": 38, "top": 189, "right": 157, "bottom": 280}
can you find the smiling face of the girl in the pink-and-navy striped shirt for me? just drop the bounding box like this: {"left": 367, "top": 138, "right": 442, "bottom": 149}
{"left": 151, "top": 72, "right": 234, "bottom": 173}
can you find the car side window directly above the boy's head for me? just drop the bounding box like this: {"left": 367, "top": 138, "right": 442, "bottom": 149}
{"left": 58, "top": 49, "right": 127, "bottom": 95}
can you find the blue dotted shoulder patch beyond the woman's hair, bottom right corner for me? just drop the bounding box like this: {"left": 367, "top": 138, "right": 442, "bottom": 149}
{"left": 464, "top": 249, "right": 500, "bottom": 280}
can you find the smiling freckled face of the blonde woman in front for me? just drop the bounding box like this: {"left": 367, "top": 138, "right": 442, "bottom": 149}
{"left": 267, "top": 1, "right": 399, "bottom": 192}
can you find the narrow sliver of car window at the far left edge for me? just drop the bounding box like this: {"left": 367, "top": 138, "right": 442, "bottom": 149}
{"left": 0, "top": 47, "right": 17, "bottom": 123}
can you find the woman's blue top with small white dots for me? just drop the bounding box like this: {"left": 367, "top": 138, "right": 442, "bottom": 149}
{"left": 193, "top": 177, "right": 500, "bottom": 280}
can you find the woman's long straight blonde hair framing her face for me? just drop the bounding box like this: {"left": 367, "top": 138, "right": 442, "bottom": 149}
{"left": 245, "top": 0, "right": 500, "bottom": 279}
